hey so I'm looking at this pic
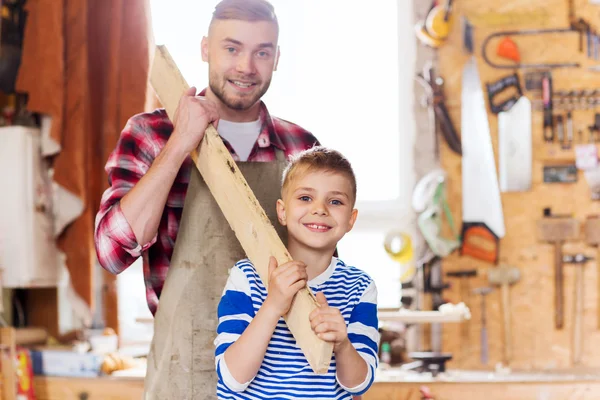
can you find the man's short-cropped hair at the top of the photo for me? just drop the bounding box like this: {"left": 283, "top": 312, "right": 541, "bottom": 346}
{"left": 209, "top": 0, "right": 279, "bottom": 31}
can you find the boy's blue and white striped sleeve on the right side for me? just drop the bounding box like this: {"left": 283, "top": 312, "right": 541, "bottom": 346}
{"left": 336, "top": 281, "right": 380, "bottom": 395}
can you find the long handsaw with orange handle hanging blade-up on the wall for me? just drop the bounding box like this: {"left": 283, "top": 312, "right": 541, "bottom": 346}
{"left": 461, "top": 19, "right": 505, "bottom": 263}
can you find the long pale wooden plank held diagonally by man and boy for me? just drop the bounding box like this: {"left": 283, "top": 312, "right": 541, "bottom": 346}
{"left": 150, "top": 46, "right": 333, "bottom": 374}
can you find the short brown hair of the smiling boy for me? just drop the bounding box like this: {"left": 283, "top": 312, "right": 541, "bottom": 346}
{"left": 281, "top": 146, "right": 356, "bottom": 204}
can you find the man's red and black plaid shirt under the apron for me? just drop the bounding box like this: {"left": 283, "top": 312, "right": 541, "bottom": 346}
{"left": 94, "top": 93, "right": 319, "bottom": 315}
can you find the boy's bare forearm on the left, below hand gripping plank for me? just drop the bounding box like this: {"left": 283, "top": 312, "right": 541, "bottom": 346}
{"left": 224, "top": 304, "right": 280, "bottom": 384}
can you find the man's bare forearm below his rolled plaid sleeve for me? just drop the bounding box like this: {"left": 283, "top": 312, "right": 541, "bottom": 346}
{"left": 121, "top": 141, "right": 187, "bottom": 246}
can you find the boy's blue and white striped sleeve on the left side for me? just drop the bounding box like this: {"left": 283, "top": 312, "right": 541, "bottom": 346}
{"left": 214, "top": 265, "right": 255, "bottom": 392}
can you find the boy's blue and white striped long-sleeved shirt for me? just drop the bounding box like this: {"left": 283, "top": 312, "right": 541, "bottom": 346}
{"left": 215, "top": 257, "right": 379, "bottom": 399}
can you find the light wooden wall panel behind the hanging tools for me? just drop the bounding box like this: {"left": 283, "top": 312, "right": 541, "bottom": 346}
{"left": 439, "top": 0, "right": 600, "bottom": 370}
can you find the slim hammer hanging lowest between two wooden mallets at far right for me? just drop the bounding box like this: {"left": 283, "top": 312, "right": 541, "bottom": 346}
{"left": 563, "top": 254, "right": 592, "bottom": 365}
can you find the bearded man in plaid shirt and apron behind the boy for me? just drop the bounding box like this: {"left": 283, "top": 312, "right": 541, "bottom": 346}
{"left": 95, "top": 0, "right": 319, "bottom": 399}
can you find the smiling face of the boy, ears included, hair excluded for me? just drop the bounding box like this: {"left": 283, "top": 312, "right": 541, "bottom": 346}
{"left": 277, "top": 171, "right": 357, "bottom": 254}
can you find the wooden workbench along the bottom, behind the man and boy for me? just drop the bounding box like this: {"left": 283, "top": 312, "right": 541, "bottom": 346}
{"left": 35, "top": 369, "right": 600, "bottom": 400}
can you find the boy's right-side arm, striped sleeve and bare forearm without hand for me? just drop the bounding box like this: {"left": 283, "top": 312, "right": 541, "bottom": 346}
{"left": 335, "top": 281, "right": 379, "bottom": 395}
